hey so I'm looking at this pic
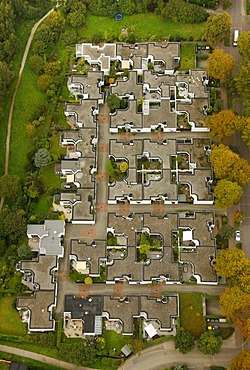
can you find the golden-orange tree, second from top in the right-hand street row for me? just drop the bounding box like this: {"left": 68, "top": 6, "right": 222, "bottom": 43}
{"left": 207, "top": 49, "right": 235, "bottom": 80}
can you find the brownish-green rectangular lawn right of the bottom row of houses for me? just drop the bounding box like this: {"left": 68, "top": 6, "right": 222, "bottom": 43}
{"left": 180, "top": 293, "right": 206, "bottom": 338}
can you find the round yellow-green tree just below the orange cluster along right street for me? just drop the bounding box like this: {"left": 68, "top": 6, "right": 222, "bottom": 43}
{"left": 214, "top": 179, "right": 243, "bottom": 208}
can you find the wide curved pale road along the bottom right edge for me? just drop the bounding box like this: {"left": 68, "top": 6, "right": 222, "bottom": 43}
{"left": 119, "top": 339, "right": 249, "bottom": 370}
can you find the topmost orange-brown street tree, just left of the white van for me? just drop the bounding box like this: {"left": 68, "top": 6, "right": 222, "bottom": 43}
{"left": 203, "top": 13, "right": 232, "bottom": 46}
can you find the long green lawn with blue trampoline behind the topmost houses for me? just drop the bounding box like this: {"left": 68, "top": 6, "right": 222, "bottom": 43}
{"left": 79, "top": 13, "right": 204, "bottom": 41}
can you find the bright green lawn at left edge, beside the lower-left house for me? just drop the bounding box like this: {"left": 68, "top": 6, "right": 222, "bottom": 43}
{"left": 0, "top": 297, "right": 27, "bottom": 336}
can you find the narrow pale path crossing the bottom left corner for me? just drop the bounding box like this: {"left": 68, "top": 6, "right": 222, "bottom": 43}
{"left": 0, "top": 345, "right": 95, "bottom": 370}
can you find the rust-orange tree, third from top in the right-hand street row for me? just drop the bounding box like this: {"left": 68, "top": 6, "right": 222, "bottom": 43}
{"left": 205, "top": 110, "right": 245, "bottom": 142}
